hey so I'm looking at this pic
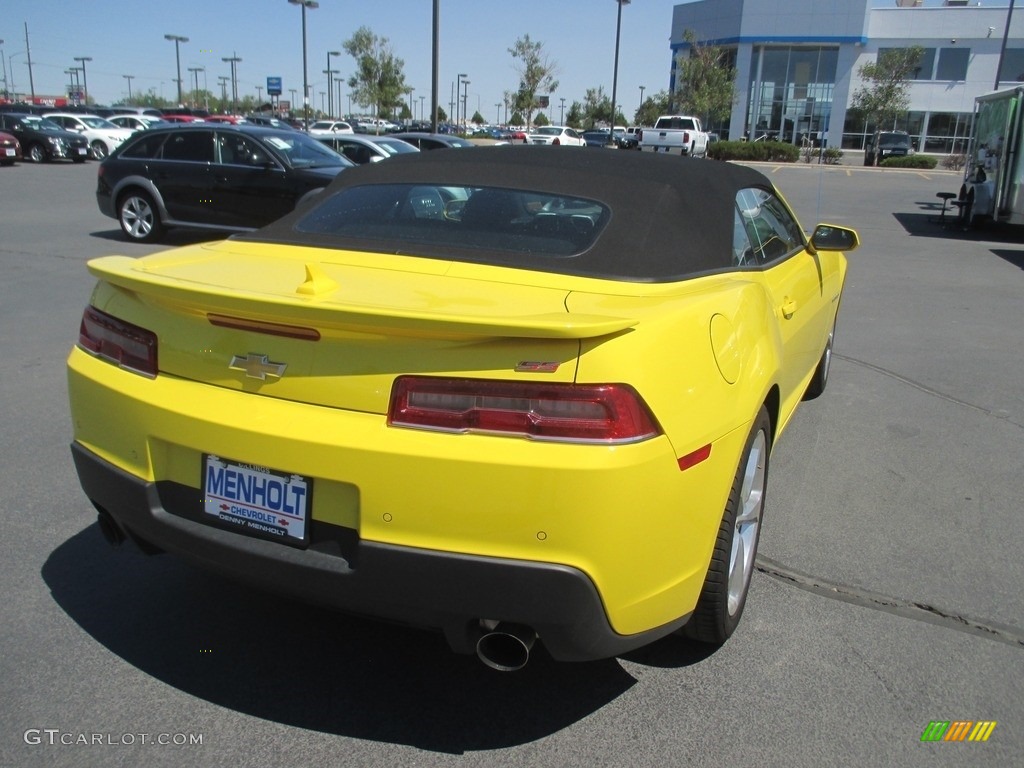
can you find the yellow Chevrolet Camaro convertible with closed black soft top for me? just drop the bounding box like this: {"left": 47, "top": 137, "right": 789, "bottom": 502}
{"left": 68, "top": 146, "right": 858, "bottom": 670}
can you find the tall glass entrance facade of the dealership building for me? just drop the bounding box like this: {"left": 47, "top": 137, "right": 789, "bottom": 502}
{"left": 745, "top": 45, "right": 839, "bottom": 144}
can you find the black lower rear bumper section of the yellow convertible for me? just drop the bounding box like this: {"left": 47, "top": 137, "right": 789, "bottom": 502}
{"left": 72, "top": 443, "right": 688, "bottom": 662}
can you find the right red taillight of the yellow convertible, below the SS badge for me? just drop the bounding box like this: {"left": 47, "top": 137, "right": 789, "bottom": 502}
{"left": 388, "top": 376, "right": 659, "bottom": 443}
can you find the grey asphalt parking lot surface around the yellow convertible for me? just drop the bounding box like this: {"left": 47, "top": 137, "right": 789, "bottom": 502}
{"left": 0, "top": 157, "right": 1024, "bottom": 768}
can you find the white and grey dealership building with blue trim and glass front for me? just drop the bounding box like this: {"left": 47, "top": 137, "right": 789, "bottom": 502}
{"left": 670, "top": 0, "right": 1024, "bottom": 154}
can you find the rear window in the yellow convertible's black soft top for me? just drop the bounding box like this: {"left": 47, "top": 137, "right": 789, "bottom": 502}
{"left": 295, "top": 183, "right": 609, "bottom": 263}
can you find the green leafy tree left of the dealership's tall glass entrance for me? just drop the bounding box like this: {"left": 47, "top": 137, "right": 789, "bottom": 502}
{"left": 663, "top": 30, "right": 736, "bottom": 124}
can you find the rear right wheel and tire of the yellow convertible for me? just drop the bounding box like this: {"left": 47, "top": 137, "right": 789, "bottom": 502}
{"left": 682, "top": 406, "right": 771, "bottom": 645}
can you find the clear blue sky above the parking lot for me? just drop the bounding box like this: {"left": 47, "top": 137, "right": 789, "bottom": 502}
{"left": 0, "top": 0, "right": 692, "bottom": 121}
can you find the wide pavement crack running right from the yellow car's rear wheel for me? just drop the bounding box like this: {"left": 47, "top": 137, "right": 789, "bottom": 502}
{"left": 756, "top": 555, "right": 1024, "bottom": 648}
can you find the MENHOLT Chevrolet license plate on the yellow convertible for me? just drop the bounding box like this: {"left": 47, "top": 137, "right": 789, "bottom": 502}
{"left": 203, "top": 455, "right": 312, "bottom": 545}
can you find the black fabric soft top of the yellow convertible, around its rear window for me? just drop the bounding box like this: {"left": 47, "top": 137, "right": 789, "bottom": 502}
{"left": 245, "top": 145, "right": 774, "bottom": 282}
